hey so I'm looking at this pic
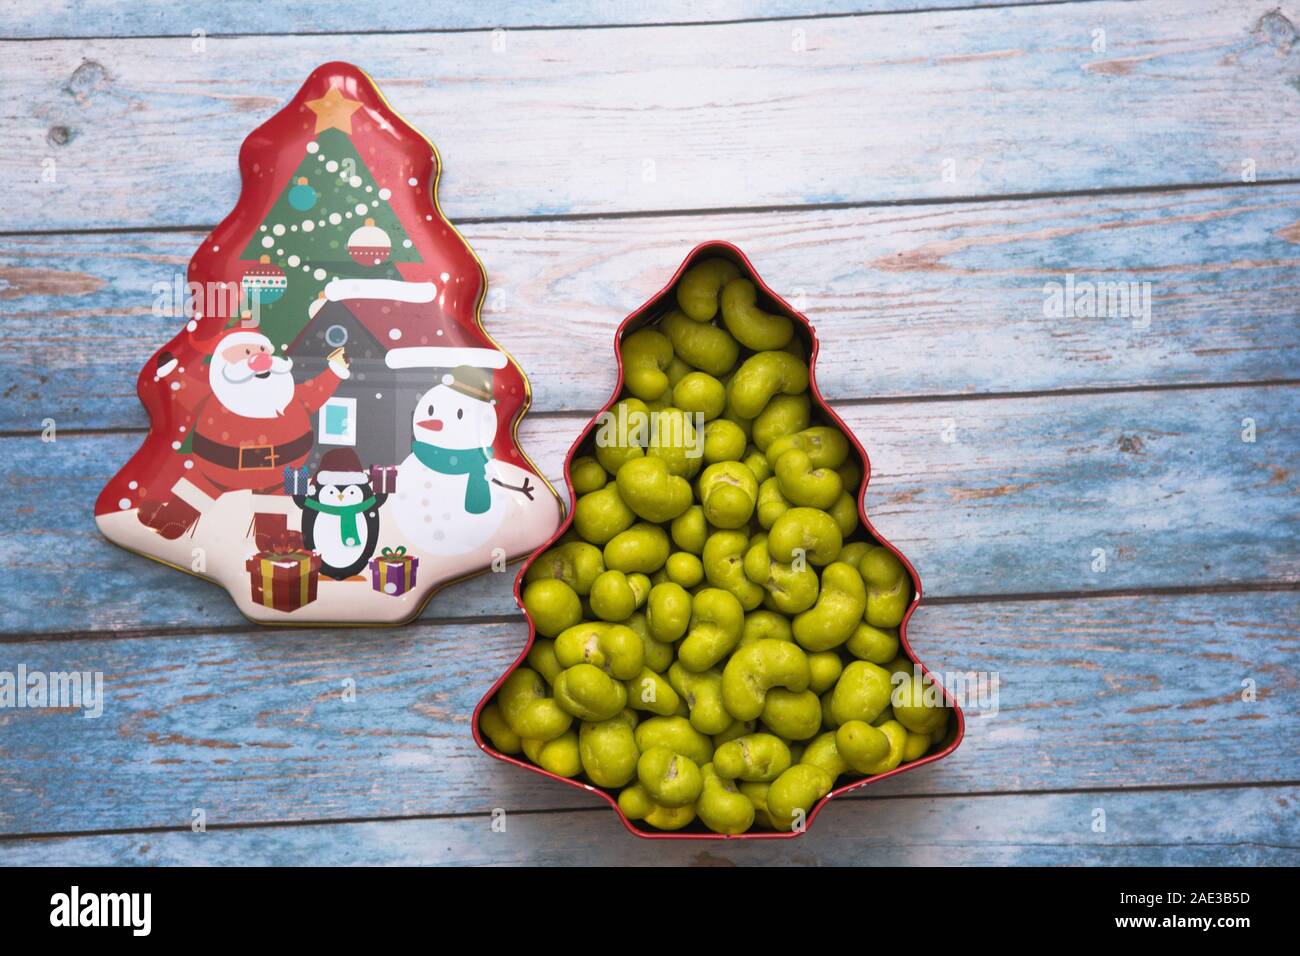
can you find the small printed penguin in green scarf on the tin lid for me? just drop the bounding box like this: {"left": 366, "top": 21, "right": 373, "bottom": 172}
{"left": 293, "top": 449, "right": 389, "bottom": 581}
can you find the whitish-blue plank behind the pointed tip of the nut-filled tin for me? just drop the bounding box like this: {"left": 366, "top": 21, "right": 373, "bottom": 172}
{"left": 0, "top": 186, "right": 1300, "bottom": 431}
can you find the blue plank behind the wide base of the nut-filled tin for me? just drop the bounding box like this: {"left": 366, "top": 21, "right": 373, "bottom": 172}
{"left": 0, "top": 591, "right": 1300, "bottom": 834}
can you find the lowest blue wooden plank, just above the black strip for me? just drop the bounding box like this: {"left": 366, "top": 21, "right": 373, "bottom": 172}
{"left": 0, "top": 787, "right": 1300, "bottom": 866}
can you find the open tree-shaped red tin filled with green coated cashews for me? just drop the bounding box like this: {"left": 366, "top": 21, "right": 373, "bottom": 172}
{"left": 473, "top": 242, "right": 965, "bottom": 839}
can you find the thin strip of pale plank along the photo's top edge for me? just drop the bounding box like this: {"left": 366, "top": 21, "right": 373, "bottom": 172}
{"left": 0, "top": 0, "right": 1044, "bottom": 38}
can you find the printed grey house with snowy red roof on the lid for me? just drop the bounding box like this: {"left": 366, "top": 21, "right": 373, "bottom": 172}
{"left": 287, "top": 278, "right": 506, "bottom": 472}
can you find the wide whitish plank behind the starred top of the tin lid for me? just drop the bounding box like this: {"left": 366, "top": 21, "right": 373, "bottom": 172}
{"left": 0, "top": 0, "right": 1300, "bottom": 232}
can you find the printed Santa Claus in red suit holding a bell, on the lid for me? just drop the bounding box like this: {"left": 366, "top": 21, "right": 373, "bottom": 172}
{"left": 139, "top": 328, "right": 351, "bottom": 538}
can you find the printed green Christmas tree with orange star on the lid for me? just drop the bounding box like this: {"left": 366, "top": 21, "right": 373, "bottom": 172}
{"left": 241, "top": 87, "right": 421, "bottom": 350}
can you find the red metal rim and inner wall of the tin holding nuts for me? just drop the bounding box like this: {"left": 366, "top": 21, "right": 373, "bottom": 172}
{"left": 472, "top": 241, "right": 966, "bottom": 840}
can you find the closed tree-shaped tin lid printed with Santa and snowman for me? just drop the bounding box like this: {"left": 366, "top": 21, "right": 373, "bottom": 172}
{"left": 95, "top": 62, "right": 563, "bottom": 624}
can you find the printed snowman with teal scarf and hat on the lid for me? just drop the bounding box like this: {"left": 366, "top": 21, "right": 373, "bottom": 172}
{"left": 389, "top": 365, "right": 537, "bottom": 555}
